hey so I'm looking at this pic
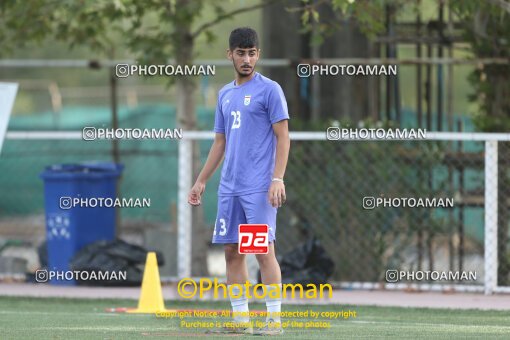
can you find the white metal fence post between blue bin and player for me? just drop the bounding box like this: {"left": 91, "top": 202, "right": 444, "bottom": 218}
{"left": 177, "top": 139, "right": 193, "bottom": 278}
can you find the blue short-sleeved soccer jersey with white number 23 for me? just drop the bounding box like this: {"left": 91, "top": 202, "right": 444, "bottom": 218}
{"left": 214, "top": 73, "right": 289, "bottom": 196}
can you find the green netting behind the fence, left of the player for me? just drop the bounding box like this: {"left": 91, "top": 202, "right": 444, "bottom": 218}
{"left": 0, "top": 104, "right": 218, "bottom": 223}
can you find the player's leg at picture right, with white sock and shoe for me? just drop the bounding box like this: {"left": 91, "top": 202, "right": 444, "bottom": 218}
{"left": 254, "top": 242, "right": 283, "bottom": 335}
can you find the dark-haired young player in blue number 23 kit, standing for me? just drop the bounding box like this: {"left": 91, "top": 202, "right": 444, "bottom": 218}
{"left": 188, "top": 27, "right": 290, "bottom": 335}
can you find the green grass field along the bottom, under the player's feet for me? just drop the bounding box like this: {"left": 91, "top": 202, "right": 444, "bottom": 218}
{"left": 0, "top": 297, "right": 510, "bottom": 339}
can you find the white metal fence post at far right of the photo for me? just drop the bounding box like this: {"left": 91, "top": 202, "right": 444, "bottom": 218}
{"left": 484, "top": 140, "right": 498, "bottom": 295}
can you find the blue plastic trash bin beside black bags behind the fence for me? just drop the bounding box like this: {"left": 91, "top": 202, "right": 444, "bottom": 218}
{"left": 40, "top": 162, "right": 123, "bottom": 285}
